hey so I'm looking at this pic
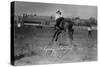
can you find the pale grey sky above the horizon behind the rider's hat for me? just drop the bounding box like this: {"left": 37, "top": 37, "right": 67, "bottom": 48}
{"left": 15, "top": 2, "right": 97, "bottom": 19}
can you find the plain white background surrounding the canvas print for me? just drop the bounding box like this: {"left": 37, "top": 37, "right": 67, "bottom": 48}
{"left": 0, "top": 0, "right": 100, "bottom": 67}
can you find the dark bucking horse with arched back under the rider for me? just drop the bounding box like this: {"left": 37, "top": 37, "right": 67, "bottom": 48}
{"left": 52, "top": 17, "right": 74, "bottom": 41}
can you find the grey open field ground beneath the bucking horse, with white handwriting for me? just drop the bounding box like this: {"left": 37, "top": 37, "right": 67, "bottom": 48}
{"left": 14, "top": 26, "right": 97, "bottom": 65}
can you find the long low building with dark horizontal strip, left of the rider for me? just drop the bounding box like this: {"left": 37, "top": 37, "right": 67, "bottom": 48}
{"left": 23, "top": 15, "right": 55, "bottom": 26}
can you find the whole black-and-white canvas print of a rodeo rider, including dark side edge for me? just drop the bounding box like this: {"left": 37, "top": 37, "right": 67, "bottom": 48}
{"left": 11, "top": 1, "right": 98, "bottom": 66}
